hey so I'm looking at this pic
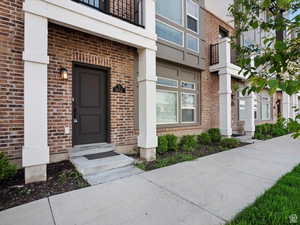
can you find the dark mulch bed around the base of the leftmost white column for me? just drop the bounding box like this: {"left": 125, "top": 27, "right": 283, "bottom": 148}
{"left": 0, "top": 161, "right": 89, "bottom": 211}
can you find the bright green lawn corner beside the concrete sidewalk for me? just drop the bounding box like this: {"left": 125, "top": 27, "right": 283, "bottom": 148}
{"left": 227, "top": 165, "right": 300, "bottom": 225}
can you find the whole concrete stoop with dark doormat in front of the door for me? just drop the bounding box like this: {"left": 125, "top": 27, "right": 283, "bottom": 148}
{"left": 69, "top": 143, "right": 143, "bottom": 185}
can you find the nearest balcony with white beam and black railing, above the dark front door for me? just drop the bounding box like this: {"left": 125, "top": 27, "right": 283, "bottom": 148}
{"left": 23, "top": 0, "right": 157, "bottom": 51}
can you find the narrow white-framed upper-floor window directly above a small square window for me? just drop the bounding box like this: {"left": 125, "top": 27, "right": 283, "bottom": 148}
{"left": 186, "top": 0, "right": 199, "bottom": 33}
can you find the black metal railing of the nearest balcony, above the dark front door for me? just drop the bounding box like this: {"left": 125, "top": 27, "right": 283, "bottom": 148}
{"left": 73, "top": 0, "right": 144, "bottom": 27}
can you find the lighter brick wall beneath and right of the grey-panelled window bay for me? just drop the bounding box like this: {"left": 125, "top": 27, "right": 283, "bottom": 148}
{"left": 158, "top": 10, "right": 237, "bottom": 136}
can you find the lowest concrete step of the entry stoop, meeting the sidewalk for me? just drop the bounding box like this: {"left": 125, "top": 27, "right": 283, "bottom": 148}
{"left": 84, "top": 165, "right": 144, "bottom": 185}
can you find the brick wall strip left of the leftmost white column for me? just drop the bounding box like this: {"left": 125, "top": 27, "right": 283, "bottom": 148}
{"left": 0, "top": 0, "right": 24, "bottom": 159}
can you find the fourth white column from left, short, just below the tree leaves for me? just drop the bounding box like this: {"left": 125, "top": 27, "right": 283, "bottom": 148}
{"left": 243, "top": 93, "right": 255, "bottom": 136}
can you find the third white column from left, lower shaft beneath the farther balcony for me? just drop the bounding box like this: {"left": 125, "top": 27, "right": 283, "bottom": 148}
{"left": 219, "top": 69, "right": 232, "bottom": 137}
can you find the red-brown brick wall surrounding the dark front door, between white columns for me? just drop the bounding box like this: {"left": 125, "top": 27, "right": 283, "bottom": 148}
{"left": 48, "top": 24, "right": 137, "bottom": 153}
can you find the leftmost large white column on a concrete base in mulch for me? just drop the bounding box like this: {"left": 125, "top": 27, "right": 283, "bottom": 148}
{"left": 22, "top": 12, "right": 49, "bottom": 183}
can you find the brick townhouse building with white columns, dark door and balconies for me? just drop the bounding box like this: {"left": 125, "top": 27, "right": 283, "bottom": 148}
{"left": 0, "top": 0, "right": 292, "bottom": 185}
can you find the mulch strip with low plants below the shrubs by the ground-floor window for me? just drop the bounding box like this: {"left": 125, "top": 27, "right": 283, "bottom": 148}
{"left": 137, "top": 143, "right": 249, "bottom": 171}
